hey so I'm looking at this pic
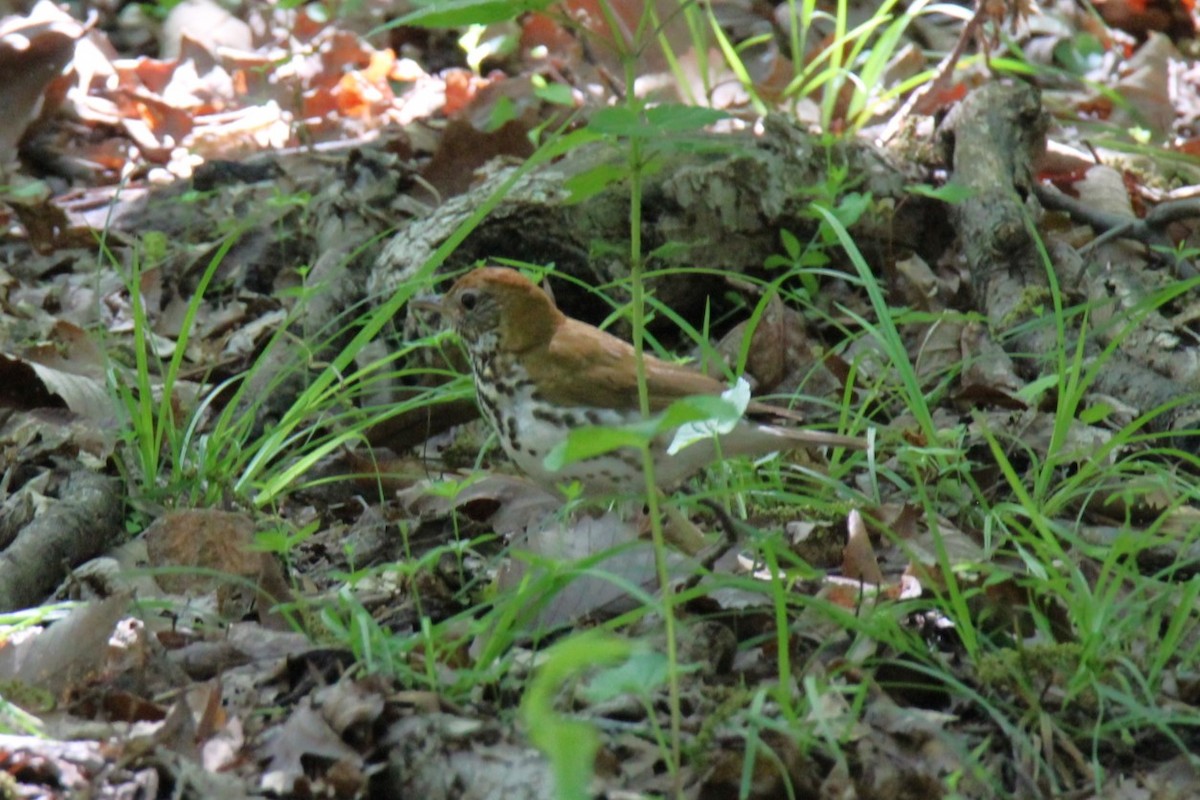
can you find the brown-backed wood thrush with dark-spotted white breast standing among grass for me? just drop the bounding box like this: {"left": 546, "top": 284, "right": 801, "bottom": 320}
{"left": 425, "top": 267, "right": 865, "bottom": 494}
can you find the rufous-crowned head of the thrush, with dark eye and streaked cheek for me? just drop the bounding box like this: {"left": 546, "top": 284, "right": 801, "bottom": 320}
{"left": 440, "top": 266, "right": 565, "bottom": 353}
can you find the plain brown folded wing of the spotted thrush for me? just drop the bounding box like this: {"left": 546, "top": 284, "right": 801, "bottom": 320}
{"left": 535, "top": 319, "right": 725, "bottom": 410}
